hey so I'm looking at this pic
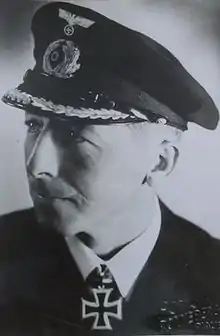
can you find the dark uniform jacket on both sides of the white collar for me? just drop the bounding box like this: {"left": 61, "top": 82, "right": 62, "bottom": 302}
{"left": 0, "top": 205, "right": 220, "bottom": 336}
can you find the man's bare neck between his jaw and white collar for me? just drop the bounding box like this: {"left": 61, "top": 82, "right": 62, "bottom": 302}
{"left": 81, "top": 188, "right": 160, "bottom": 257}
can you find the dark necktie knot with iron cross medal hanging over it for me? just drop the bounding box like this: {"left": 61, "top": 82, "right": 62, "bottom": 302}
{"left": 82, "top": 265, "right": 122, "bottom": 330}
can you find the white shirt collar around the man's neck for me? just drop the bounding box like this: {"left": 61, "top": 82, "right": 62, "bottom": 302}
{"left": 66, "top": 203, "right": 161, "bottom": 298}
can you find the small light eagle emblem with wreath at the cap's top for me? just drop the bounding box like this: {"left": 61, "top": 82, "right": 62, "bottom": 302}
{"left": 59, "top": 8, "right": 95, "bottom": 36}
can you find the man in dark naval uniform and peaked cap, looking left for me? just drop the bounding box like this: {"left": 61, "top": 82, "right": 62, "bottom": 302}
{"left": 0, "top": 2, "right": 220, "bottom": 335}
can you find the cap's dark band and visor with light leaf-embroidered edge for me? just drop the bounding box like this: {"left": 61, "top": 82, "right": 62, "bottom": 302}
{"left": 3, "top": 69, "right": 187, "bottom": 130}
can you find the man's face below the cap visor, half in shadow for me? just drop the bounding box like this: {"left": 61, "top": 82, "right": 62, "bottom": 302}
{"left": 25, "top": 113, "right": 175, "bottom": 248}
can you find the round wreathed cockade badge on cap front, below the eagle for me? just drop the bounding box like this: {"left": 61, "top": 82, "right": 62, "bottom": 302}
{"left": 43, "top": 39, "right": 81, "bottom": 79}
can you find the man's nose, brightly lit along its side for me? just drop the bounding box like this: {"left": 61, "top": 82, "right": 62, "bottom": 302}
{"left": 27, "top": 130, "right": 59, "bottom": 177}
